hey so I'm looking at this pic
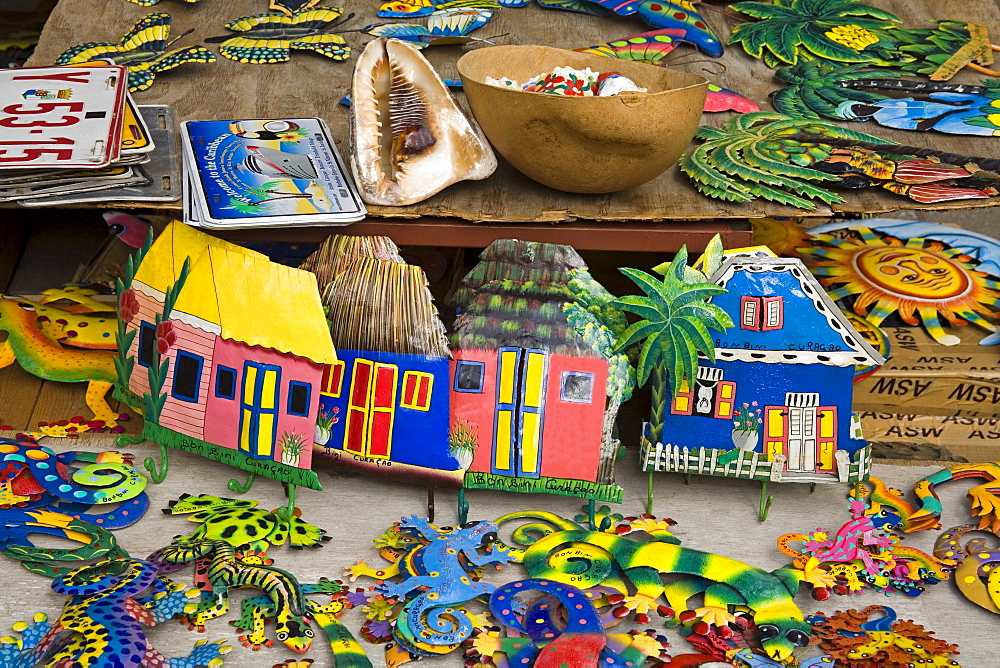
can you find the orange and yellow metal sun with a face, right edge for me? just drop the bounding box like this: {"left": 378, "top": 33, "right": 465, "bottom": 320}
{"left": 810, "top": 228, "right": 1000, "bottom": 346}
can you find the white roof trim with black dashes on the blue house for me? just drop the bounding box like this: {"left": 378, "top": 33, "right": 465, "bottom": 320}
{"left": 710, "top": 257, "right": 885, "bottom": 366}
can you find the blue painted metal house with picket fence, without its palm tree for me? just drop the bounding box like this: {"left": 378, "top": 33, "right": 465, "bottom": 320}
{"left": 643, "top": 251, "right": 885, "bottom": 482}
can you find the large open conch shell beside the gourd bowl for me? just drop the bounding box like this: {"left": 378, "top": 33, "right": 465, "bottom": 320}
{"left": 351, "top": 38, "right": 497, "bottom": 206}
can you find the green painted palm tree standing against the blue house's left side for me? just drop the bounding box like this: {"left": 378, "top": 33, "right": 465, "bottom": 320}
{"left": 615, "top": 246, "right": 733, "bottom": 443}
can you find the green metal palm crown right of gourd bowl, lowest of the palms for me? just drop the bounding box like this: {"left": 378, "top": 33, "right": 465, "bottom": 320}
{"left": 680, "top": 112, "right": 888, "bottom": 209}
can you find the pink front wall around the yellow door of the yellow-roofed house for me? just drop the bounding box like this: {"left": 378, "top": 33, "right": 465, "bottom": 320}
{"left": 204, "top": 338, "right": 323, "bottom": 469}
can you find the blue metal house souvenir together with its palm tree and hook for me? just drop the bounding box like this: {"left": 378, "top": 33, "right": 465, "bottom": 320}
{"left": 632, "top": 248, "right": 884, "bottom": 520}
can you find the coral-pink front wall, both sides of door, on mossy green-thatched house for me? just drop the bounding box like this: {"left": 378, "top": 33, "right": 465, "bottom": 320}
{"left": 450, "top": 350, "right": 608, "bottom": 481}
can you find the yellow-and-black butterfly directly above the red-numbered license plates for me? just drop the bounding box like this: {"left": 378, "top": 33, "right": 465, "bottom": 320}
{"left": 56, "top": 12, "right": 216, "bottom": 93}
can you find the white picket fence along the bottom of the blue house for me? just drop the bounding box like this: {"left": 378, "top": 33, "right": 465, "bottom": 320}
{"left": 642, "top": 438, "right": 871, "bottom": 482}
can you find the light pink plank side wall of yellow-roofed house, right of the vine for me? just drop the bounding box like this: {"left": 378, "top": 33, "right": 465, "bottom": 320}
{"left": 158, "top": 320, "right": 215, "bottom": 440}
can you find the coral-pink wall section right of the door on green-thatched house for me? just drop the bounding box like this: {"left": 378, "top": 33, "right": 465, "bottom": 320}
{"left": 541, "top": 355, "right": 608, "bottom": 482}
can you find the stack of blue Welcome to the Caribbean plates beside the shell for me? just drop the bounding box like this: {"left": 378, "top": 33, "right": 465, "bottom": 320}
{"left": 180, "top": 118, "right": 367, "bottom": 229}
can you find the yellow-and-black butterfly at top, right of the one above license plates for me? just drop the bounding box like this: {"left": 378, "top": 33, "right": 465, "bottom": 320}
{"left": 205, "top": 7, "right": 354, "bottom": 63}
